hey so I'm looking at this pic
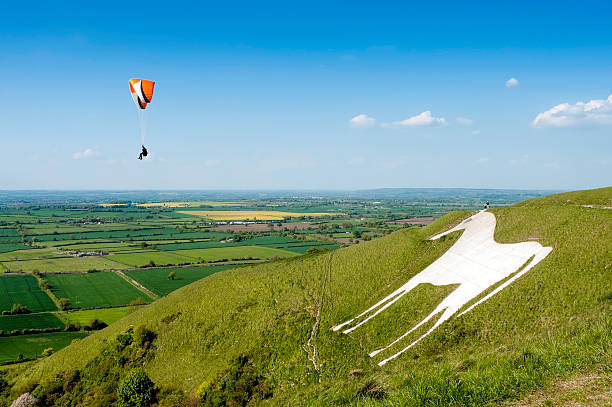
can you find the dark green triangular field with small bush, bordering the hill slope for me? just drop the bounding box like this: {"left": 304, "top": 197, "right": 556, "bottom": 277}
{"left": 125, "top": 265, "right": 235, "bottom": 296}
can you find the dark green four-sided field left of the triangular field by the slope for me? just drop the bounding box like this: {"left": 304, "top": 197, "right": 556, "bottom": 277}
{"left": 43, "top": 272, "right": 151, "bottom": 308}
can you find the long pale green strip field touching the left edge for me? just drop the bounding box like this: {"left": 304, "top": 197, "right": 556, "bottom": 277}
{"left": 2, "top": 256, "right": 122, "bottom": 273}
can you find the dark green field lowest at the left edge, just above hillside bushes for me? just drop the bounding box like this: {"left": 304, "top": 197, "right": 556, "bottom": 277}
{"left": 0, "top": 332, "right": 87, "bottom": 363}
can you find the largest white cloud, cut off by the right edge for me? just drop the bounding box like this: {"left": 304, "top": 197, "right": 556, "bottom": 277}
{"left": 531, "top": 95, "right": 612, "bottom": 127}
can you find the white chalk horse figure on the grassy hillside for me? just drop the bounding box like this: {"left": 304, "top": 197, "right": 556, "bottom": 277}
{"left": 332, "top": 210, "right": 552, "bottom": 366}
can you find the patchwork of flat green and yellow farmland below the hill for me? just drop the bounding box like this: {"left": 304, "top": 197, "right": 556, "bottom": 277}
{"left": 0, "top": 192, "right": 524, "bottom": 363}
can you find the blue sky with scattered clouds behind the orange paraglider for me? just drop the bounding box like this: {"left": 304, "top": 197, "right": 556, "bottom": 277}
{"left": 0, "top": 1, "right": 612, "bottom": 189}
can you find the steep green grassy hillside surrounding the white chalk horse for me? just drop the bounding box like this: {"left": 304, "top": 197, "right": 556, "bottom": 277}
{"left": 4, "top": 188, "right": 612, "bottom": 406}
